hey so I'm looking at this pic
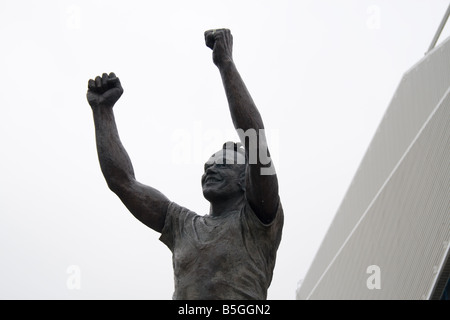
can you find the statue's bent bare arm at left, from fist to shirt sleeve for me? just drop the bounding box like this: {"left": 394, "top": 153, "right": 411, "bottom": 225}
{"left": 87, "top": 73, "right": 169, "bottom": 232}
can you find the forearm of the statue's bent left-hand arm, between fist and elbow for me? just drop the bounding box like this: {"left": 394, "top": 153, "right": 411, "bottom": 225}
{"left": 93, "top": 107, "right": 134, "bottom": 192}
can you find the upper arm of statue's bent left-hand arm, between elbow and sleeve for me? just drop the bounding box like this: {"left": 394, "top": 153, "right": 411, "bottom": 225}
{"left": 111, "top": 180, "right": 170, "bottom": 232}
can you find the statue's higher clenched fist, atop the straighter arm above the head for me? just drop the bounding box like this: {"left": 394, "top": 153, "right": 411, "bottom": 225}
{"left": 205, "top": 29, "right": 233, "bottom": 67}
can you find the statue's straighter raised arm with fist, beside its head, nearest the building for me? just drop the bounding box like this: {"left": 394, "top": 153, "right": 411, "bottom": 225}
{"left": 205, "top": 29, "right": 280, "bottom": 223}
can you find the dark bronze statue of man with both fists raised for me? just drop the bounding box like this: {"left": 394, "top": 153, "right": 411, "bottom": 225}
{"left": 87, "top": 29, "right": 284, "bottom": 300}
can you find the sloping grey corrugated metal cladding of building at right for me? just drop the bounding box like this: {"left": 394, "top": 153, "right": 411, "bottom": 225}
{"left": 297, "top": 38, "right": 450, "bottom": 299}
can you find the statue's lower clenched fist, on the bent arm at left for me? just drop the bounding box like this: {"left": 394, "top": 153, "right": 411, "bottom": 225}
{"left": 86, "top": 72, "right": 123, "bottom": 109}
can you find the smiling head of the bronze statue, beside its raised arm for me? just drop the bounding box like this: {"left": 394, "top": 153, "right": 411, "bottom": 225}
{"left": 202, "top": 142, "right": 246, "bottom": 202}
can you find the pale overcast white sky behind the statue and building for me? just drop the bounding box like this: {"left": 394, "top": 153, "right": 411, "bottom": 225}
{"left": 0, "top": 0, "right": 450, "bottom": 299}
